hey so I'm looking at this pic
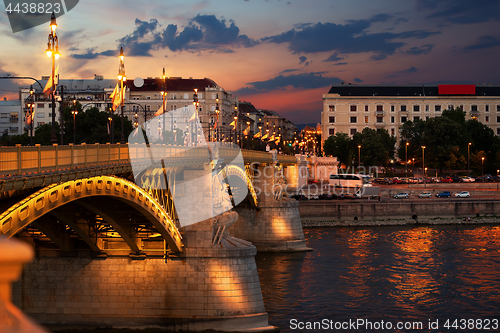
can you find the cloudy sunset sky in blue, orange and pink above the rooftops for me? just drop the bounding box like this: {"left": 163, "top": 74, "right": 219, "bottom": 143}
{"left": 0, "top": 0, "right": 500, "bottom": 124}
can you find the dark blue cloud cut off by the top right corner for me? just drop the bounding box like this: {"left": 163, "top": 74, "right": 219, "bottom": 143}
{"left": 417, "top": 0, "right": 500, "bottom": 24}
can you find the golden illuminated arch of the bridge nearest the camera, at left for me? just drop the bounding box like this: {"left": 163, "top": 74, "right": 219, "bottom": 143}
{"left": 0, "top": 176, "right": 182, "bottom": 252}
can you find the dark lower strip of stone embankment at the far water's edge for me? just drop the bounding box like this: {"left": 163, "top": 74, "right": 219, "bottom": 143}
{"left": 302, "top": 216, "right": 500, "bottom": 228}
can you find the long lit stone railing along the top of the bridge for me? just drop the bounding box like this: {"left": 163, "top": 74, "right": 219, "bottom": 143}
{"left": 0, "top": 143, "right": 296, "bottom": 177}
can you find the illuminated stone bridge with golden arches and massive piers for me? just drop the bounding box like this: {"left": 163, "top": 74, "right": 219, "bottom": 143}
{"left": 0, "top": 144, "right": 308, "bottom": 331}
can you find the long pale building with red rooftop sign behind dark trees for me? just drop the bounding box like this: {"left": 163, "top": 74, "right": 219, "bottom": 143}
{"left": 321, "top": 84, "right": 500, "bottom": 143}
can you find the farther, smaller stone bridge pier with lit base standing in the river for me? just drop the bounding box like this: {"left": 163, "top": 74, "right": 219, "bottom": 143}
{"left": 229, "top": 165, "right": 311, "bottom": 252}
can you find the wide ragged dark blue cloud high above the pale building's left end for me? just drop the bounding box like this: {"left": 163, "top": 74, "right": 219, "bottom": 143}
{"left": 261, "top": 20, "right": 440, "bottom": 59}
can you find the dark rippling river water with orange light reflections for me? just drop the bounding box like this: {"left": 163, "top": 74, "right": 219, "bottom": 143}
{"left": 257, "top": 226, "right": 500, "bottom": 332}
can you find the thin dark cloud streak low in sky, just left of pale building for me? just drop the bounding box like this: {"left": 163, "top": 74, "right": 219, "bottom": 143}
{"left": 236, "top": 72, "right": 343, "bottom": 94}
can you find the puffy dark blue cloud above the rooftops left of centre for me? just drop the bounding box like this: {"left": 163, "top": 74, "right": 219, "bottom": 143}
{"left": 71, "top": 14, "right": 259, "bottom": 59}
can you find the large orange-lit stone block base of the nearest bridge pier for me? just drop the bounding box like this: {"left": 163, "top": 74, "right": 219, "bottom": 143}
{"left": 13, "top": 246, "right": 267, "bottom": 331}
